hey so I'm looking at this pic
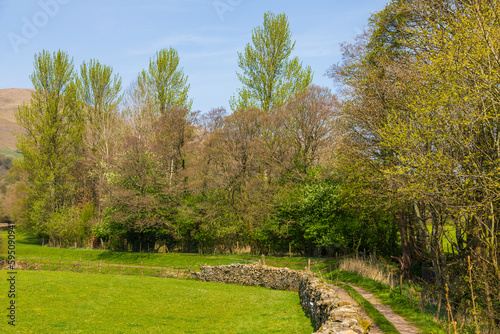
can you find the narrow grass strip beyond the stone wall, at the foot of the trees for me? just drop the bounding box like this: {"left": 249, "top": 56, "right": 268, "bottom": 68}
{"left": 1, "top": 231, "right": 333, "bottom": 270}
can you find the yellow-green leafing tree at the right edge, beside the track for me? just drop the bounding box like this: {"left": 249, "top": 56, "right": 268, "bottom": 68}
{"left": 376, "top": 0, "right": 500, "bottom": 324}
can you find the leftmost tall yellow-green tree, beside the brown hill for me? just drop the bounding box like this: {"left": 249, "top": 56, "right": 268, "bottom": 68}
{"left": 16, "top": 51, "right": 85, "bottom": 235}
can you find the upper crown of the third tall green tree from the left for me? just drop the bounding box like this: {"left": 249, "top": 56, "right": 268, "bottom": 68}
{"left": 138, "top": 48, "right": 193, "bottom": 115}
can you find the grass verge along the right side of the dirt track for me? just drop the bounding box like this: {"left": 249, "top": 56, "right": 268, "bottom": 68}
{"left": 325, "top": 270, "right": 446, "bottom": 334}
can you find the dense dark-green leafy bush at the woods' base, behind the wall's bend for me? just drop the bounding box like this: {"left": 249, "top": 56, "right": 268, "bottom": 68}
{"left": 257, "top": 179, "right": 397, "bottom": 256}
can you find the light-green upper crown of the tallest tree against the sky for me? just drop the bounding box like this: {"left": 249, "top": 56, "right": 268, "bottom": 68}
{"left": 230, "top": 12, "right": 312, "bottom": 112}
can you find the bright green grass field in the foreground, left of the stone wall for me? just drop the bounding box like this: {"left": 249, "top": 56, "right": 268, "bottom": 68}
{"left": 0, "top": 271, "right": 313, "bottom": 333}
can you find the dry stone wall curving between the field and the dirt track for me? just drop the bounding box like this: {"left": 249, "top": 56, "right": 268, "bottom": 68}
{"left": 193, "top": 264, "right": 369, "bottom": 334}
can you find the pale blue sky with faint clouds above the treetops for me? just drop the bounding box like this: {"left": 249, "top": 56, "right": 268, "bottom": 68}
{"left": 0, "top": 0, "right": 388, "bottom": 112}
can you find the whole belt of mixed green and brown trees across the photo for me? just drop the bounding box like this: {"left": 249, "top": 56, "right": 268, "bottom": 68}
{"left": 3, "top": 0, "right": 500, "bottom": 326}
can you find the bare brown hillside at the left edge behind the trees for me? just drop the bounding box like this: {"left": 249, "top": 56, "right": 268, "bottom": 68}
{"left": 0, "top": 88, "right": 33, "bottom": 153}
